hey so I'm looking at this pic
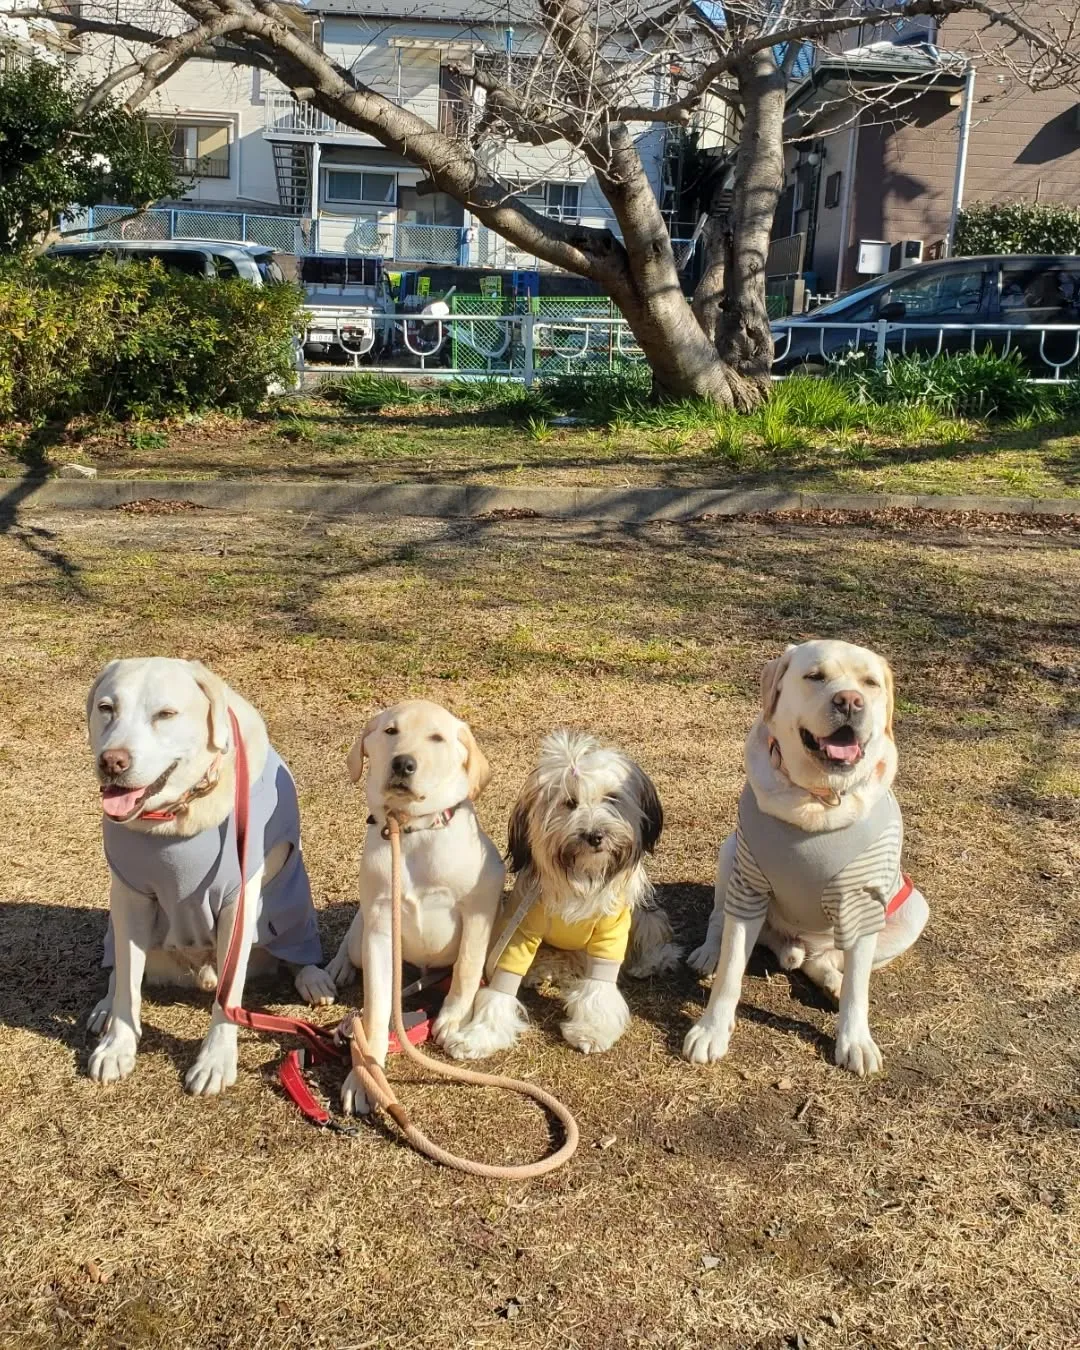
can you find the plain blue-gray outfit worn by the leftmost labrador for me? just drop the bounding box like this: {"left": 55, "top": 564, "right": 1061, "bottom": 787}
{"left": 103, "top": 747, "right": 323, "bottom": 967}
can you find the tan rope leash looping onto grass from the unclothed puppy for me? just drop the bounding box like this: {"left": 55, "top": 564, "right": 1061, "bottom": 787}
{"left": 350, "top": 815, "right": 581, "bottom": 1181}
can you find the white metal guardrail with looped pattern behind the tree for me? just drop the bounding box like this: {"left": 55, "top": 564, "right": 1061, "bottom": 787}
{"left": 300, "top": 309, "right": 1080, "bottom": 385}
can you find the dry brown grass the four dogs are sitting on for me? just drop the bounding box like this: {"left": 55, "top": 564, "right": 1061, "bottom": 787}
{"left": 0, "top": 512, "right": 1080, "bottom": 1350}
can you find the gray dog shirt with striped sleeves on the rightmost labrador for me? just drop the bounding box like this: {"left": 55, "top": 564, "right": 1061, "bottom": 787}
{"left": 724, "top": 783, "right": 905, "bottom": 952}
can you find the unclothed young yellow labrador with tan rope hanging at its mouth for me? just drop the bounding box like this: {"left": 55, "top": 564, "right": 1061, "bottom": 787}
{"left": 327, "top": 699, "right": 506, "bottom": 1115}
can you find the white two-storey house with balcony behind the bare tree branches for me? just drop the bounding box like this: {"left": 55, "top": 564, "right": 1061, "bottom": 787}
{"left": 75, "top": 0, "right": 707, "bottom": 267}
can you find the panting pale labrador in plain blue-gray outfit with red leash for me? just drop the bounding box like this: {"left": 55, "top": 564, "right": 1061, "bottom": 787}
{"left": 86, "top": 657, "right": 335, "bottom": 1094}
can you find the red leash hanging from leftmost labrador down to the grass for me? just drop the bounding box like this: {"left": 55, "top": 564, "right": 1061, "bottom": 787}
{"left": 217, "top": 709, "right": 448, "bottom": 1130}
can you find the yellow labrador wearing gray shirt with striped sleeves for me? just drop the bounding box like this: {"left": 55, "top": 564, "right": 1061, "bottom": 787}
{"left": 683, "top": 641, "right": 929, "bottom": 1076}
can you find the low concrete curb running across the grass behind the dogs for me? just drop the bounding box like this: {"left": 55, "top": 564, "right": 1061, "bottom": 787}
{"left": 0, "top": 478, "right": 1080, "bottom": 524}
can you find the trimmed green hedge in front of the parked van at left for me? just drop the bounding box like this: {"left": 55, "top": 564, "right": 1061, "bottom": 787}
{"left": 0, "top": 259, "right": 300, "bottom": 423}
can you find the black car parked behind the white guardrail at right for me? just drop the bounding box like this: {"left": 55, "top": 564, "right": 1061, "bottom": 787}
{"left": 771, "top": 254, "right": 1080, "bottom": 379}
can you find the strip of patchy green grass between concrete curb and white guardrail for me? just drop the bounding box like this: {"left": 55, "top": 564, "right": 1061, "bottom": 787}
{"left": 0, "top": 400, "right": 1080, "bottom": 497}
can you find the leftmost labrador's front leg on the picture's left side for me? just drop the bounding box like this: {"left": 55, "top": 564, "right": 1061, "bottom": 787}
{"left": 89, "top": 876, "right": 157, "bottom": 1083}
